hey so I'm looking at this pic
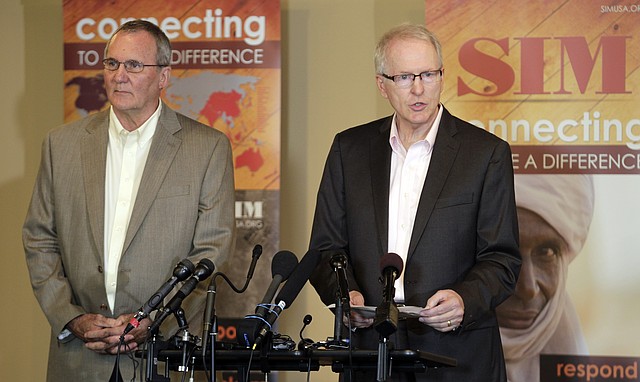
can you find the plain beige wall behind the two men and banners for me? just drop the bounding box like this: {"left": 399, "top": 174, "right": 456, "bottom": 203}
{"left": 0, "top": 0, "right": 424, "bottom": 381}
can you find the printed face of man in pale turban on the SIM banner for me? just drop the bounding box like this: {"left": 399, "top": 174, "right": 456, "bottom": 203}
{"left": 497, "top": 175, "right": 595, "bottom": 382}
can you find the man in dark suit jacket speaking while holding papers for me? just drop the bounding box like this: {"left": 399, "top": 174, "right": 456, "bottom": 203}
{"left": 310, "top": 25, "right": 521, "bottom": 382}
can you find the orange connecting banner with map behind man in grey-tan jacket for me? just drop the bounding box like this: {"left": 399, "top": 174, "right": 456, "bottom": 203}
{"left": 63, "top": 0, "right": 281, "bottom": 317}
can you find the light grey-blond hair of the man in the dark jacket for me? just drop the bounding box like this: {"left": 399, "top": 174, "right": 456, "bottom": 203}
{"left": 373, "top": 24, "right": 443, "bottom": 74}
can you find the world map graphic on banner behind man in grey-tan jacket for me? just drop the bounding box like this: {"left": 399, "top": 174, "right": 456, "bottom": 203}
{"left": 65, "top": 72, "right": 278, "bottom": 189}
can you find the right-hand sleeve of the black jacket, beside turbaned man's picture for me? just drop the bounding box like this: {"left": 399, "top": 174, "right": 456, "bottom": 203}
{"left": 453, "top": 142, "right": 521, "bottom": 326}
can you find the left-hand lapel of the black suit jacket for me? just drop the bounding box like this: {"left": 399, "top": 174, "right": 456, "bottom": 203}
{"left": 369, "top": 117, "right": 393, "bottom": 254}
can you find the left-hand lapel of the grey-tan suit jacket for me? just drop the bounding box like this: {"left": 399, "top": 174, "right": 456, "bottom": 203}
{"left": 80, "top": 110, "right": 109, "bottom": 263}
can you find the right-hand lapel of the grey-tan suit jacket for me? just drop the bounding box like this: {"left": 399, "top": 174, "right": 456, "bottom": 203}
{"left": 122, "top": 104, "right": 182, "bottom": 254}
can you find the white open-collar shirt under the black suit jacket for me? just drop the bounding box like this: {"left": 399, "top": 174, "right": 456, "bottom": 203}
{"left": 388, "top": 106, "right": 443, "bottom": 303}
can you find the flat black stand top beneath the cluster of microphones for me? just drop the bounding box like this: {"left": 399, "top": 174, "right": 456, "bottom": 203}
{"left": 147, "top": 349, "right": 456, "bottom": 382}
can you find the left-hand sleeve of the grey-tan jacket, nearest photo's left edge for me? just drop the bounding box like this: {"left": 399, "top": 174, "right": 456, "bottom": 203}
{"left": 22, "top": 133, "right": 85, "bottom": 333}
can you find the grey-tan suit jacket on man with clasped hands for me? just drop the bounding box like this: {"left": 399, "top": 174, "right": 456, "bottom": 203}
{"left": 23, "top": 105, "right": 235, "bottom": 381}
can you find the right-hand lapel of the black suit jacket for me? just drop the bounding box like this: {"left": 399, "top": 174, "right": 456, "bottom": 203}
{"left": 407, "top": 109, "right": 460, "bottom": 260}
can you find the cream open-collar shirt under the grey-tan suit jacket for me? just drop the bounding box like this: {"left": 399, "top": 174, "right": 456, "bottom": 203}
{"left": 104, "top": 102, "right": 162, "bottom": 312}
